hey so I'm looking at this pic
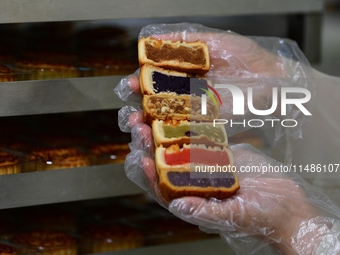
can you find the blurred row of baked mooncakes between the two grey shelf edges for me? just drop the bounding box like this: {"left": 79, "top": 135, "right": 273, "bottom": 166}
{"left": 0, "top": 143, "right": 130, "bottom": 175}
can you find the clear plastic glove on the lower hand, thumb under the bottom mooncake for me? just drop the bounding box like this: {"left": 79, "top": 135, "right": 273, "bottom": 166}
{"left": 119, "top": 118, "right": 340, "bottom": 254}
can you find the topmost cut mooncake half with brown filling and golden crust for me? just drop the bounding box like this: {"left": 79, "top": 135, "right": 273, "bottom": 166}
{"left": 138, "top": 37, "right": 210, "bottom": 75}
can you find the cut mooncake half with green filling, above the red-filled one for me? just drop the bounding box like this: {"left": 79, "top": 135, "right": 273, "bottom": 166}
{"left": 152, "top": 120, "right": 228, "bottom": 147}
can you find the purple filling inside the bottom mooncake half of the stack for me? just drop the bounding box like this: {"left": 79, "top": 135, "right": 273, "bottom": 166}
{"left": 168, "top": 172, "right": 235, "bottom": 188}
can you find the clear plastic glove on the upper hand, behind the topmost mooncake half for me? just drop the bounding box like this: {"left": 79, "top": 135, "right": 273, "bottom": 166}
{"left": 115, "top": 23, "right": 314, "bottom": 163}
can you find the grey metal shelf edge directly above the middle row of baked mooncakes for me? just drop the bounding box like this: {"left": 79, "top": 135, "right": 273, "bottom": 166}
{"left": 0, "top": 76, "right": 129, "bottom": 116}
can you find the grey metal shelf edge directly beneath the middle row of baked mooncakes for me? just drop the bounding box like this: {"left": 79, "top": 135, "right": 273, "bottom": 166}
{"left": 0, "top": 164, "right": 142, "bottom": 209}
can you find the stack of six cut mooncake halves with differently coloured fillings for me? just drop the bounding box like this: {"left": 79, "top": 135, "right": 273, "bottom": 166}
{"left": 138, "top": 37, "right": 239, "bottom": 201}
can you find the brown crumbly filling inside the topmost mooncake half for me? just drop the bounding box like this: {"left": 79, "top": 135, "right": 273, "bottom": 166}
{"left": 145, "top": 43, "right": 206, "bottom": 66}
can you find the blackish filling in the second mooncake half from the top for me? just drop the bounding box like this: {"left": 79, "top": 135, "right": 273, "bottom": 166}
{"left": 152, "top": 72, "right": 207, "bottom": 96}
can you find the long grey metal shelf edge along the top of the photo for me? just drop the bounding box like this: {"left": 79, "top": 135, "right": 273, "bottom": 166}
{"left": 0, "top": 0, "right": 323, "bottom": 23}
